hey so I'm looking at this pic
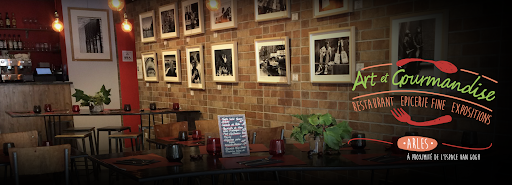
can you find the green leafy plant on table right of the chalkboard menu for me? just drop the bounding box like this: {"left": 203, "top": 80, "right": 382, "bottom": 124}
{"left": 290, "top": 113, "right": 352, "bottom": 153}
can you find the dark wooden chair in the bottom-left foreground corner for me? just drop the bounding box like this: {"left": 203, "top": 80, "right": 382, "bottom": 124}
{"left": 9, "top": 144, "right": 71, "bottom": 184}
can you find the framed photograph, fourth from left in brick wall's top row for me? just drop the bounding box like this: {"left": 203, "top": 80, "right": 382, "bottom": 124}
{"left": 210, "top": 0, "right": 238, "bottom": 31}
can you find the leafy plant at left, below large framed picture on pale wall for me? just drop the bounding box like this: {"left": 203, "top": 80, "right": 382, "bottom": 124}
{"left": 71, "top": 85, "right": 111, "bottom": 112}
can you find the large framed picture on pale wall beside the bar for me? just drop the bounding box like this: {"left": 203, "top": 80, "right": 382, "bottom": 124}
{"left": 68, "top": 7, "right": 112, "bottom": 61}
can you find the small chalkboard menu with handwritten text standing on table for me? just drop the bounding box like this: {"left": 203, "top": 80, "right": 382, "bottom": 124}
{"left": 217, "top": 114, "right": 250, "bottom": 157}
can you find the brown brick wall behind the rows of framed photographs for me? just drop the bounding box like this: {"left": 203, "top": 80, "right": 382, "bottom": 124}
{"left": 127, "top": 0, "right": 505, "bottom": 144}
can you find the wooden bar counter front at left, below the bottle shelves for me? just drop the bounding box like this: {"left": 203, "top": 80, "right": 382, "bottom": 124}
{"left": 0, "top": 81, "right": 73, "bottom": 140}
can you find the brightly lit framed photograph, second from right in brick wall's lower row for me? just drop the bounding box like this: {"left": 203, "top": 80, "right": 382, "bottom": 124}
{"left": 254, "top": 37, "right": 291, "bottom": 84}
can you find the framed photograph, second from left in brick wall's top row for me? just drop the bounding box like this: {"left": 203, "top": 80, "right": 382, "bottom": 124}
{"left": 159, "top": 3, "right": 180, "bottom": 39}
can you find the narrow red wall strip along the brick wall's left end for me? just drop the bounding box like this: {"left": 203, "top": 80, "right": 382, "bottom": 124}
{"left": 116, "top": 20, "right": 140, "bottom": 147}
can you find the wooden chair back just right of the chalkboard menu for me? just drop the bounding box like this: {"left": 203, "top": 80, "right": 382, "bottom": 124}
{"left": 247, "top": 126, "right": 284, "bottom": 145}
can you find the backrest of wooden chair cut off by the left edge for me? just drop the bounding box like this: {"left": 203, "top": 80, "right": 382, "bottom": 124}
{"left": 0, "top": 130, "right": 39, "bottom": 148}
